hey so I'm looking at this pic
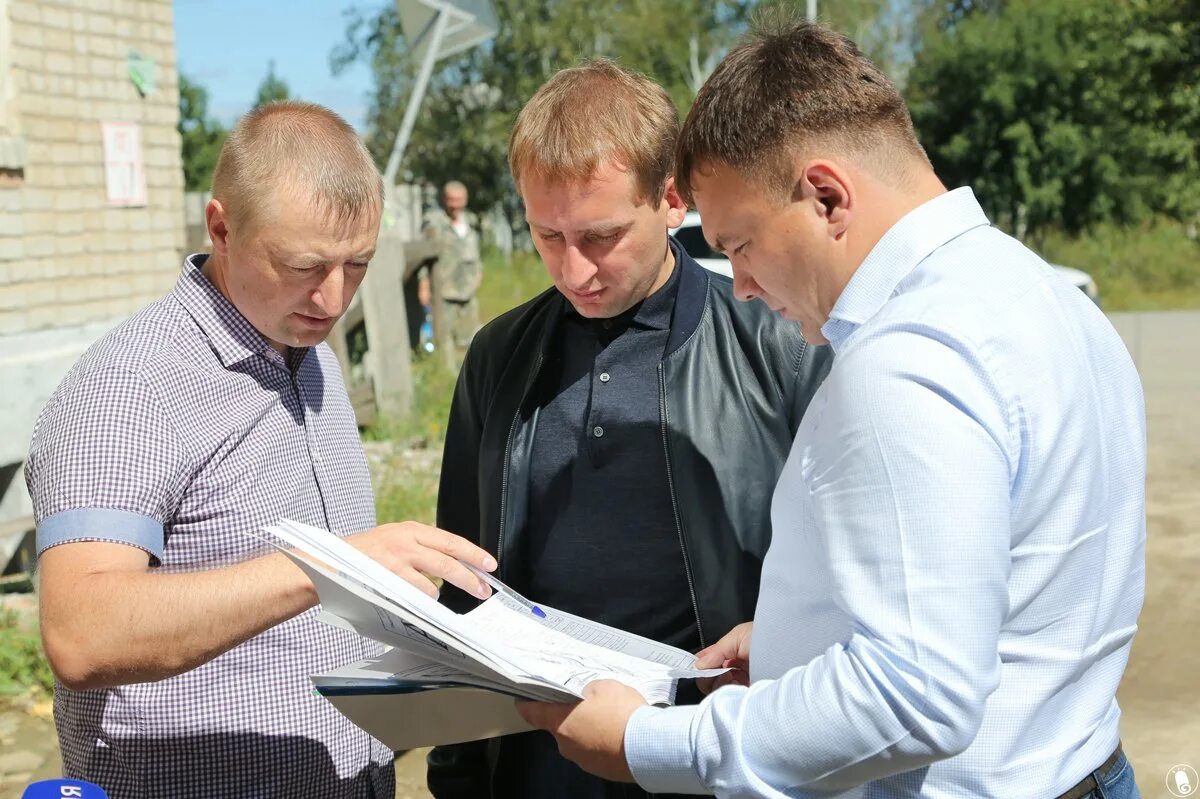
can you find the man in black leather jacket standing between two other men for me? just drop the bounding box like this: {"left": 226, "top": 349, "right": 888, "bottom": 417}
{"left": 428, "top": 61, "right": 829, "bottom": 799}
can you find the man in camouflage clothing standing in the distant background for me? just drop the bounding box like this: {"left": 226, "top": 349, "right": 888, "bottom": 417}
{"left": 425, "top": 180, "right": 484, "bottom": 353}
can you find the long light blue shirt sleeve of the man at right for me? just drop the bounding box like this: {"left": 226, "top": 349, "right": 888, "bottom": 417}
{"left": 625, "top": 324, "right": 1019, "bottom": 797}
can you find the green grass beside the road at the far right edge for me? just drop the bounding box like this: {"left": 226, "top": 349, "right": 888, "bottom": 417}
{"left": 1042, "top": 220, "right": 1200, "bottom": 311}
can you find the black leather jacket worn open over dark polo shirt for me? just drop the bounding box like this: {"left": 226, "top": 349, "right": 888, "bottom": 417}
{"left": 428, "top": 241, "right": 830, "bottom": 799}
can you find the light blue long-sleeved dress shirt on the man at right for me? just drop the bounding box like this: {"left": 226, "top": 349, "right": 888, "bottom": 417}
{"left": 625, "top": 188, "right": 1146, "bottom": 799}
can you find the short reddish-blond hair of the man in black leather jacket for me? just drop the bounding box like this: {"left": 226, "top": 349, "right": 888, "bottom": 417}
{"left": 509, "top": 59, "right": 679, "bottom": 203}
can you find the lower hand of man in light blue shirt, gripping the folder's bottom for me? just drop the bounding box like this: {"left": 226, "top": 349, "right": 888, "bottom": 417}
{"left": 517, "top": 680, "right": 646, "bottom": 782}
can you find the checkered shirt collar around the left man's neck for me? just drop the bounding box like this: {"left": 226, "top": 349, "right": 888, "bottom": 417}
{"left": 173, "top": 253, "right": 284, "bottom": 368}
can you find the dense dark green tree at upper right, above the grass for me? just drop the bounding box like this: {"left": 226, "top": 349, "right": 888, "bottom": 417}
{"left": 908, "top": 0, "right": 1200, "bottom": 238}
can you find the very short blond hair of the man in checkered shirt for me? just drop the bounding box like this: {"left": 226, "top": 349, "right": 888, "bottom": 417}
{"left": 212, "top": 101, "right": 383, "bottom": 233}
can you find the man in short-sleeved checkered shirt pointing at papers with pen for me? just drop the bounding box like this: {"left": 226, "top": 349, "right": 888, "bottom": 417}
{"left": 26, "top": 103, "right": 494, "bottom": 799}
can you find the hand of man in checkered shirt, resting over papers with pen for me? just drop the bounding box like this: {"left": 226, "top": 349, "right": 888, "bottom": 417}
{"left": 346, "top": 522, "right": 496, "bottom": 599}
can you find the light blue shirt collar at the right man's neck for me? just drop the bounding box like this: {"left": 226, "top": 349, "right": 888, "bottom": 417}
{"left": 821, "top": 186, "right": 990, "bottom": 352}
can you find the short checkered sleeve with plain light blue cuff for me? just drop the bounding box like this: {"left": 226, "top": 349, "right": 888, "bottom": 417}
{"left": 25, "top": 366, "right": 188, "bottom": 561}
